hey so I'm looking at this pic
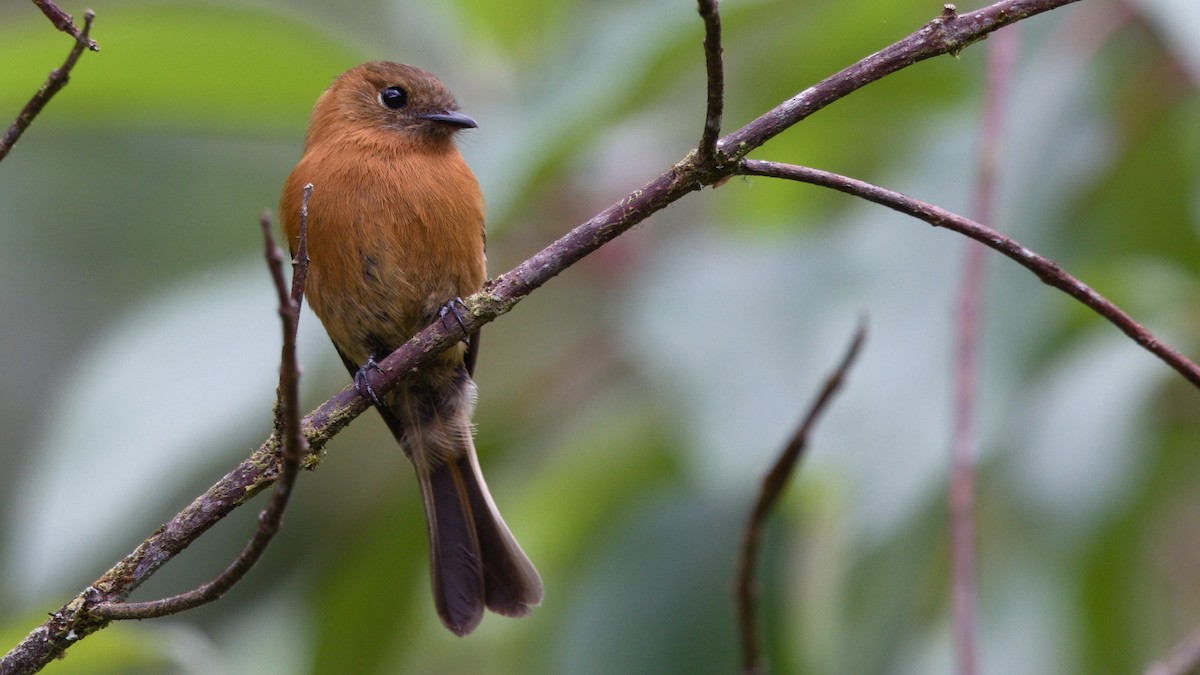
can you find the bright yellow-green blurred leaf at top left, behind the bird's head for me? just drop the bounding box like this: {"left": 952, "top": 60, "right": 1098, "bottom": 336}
{"left": 0, "top": 2, "right": 366, "bottom": 135}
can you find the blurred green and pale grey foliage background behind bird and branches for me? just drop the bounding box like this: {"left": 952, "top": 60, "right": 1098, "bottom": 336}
{"left": 0, "top": 0, "right": 1200, "bottom": 674}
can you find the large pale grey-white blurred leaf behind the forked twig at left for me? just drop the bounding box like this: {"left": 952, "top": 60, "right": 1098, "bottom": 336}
{"left": 8, "top": 261, "right": 320, "bottom": 601}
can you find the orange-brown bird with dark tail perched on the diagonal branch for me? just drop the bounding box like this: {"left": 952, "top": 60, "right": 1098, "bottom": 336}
{"left": 280, "top": 61, "right": 542, "bottom": 635}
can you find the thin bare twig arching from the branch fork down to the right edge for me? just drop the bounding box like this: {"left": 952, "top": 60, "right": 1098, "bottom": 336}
{"left": 740, "top": 160, "right": 1200, "bottom": 388}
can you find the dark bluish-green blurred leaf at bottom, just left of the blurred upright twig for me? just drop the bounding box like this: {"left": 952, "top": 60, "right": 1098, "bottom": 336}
{"left": 553, "top": 494, "right": 743, "bottom": 674}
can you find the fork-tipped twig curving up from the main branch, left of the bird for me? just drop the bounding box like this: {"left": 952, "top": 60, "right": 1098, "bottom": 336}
{"left": 90, "top": 193, "right": 312, "bottom": 621}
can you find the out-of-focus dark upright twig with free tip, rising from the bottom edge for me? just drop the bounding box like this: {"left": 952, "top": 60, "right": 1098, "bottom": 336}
{"left": 737, "top": 318, "right": 866, "bottom": 675}
